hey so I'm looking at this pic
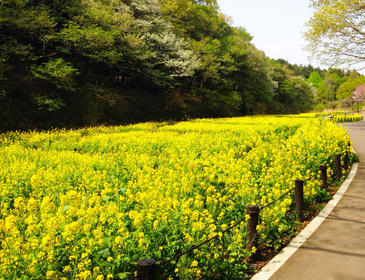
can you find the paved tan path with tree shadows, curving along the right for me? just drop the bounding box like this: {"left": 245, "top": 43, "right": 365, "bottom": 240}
{"left": 271, "top": 121, "right": 365, "bottom": 280}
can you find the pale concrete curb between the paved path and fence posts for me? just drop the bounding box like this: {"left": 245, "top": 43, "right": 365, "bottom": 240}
{"left": 251, "top": 163, "right": 359, "bottom": 280}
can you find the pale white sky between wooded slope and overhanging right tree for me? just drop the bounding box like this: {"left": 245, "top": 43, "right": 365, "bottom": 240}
{"left": 218, "top": 0, "right": 320, "bottom": 66}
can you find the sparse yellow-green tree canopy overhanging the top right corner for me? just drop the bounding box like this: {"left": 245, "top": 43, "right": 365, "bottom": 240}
{"left": 305, "top": 0, "right": 365, "bottom": 67}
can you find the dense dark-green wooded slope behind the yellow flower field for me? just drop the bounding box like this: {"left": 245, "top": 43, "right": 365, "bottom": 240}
{"left": 0, "top": 0, "right": 338, "bottom": 130}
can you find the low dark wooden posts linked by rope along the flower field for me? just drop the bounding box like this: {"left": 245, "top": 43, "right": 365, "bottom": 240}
{"left": 132, "top": 149, "right": 351, "bottom": 280}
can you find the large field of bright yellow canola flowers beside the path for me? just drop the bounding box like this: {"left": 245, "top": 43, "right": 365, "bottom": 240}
{"left": 0, "top": 116, "right": 349, "bottom": 280}
